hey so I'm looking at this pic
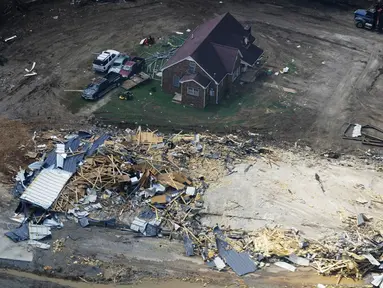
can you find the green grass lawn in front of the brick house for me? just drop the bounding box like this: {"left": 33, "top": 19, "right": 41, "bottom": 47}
{"left": 95, "top": 80, "right": 254, "bottom": 129}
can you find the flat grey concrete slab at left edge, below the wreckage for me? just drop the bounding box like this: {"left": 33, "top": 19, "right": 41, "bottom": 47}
{"left": 0, "top": 234, "right": 33, "bottom": 262}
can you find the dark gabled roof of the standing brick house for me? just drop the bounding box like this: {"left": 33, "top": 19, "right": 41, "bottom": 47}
{"left": 164, "top": 13, "right": 263, "bottom": 82}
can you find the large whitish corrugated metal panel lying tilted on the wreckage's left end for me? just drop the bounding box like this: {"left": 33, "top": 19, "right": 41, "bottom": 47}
{"left": 20, "top": 169, "right": 72, "bottom": 209}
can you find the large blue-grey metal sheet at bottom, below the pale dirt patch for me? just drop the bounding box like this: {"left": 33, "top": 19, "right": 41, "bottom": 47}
{"left": 216, "top": 238, "right": 257, "bottom": 276}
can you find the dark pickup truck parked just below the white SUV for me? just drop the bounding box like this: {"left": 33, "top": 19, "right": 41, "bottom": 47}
{"left": 81, "top": 72, "right": 125, "bottom": 100}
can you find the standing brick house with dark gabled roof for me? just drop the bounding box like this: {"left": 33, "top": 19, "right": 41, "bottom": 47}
{"left": 162, "top": 13, "right": 263, "bottom": 108}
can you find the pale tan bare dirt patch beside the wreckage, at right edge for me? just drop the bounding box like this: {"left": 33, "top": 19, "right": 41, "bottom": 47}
{"left": 204, "top": 148, "right": 383, "bottom": 240}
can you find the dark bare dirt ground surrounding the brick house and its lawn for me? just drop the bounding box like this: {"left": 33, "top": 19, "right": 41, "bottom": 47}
{"left": 0, "top": 0, "right": 383, "bottom": 149}
